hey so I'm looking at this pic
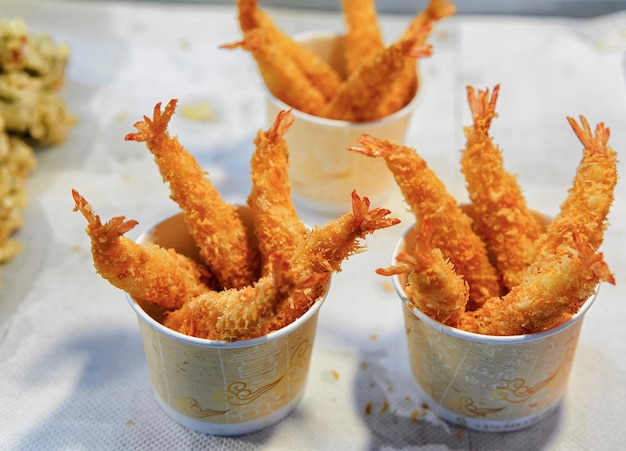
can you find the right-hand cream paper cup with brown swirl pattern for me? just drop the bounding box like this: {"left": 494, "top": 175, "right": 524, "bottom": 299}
{"left": 393, "top": 224, "right": 595, "bottom": 431}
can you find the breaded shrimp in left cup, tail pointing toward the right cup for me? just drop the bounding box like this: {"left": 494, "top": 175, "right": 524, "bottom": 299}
{"left": 255, "top": 191, "right": 400, "bottom": 330}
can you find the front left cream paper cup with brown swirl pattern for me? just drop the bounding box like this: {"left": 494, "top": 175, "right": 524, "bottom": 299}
{"left": 129, "top": 215, "right": 330, "bottom": 435}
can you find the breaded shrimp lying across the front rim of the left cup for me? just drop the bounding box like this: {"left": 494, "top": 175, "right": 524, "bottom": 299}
{"left": 164, "top": 254, "right": 329, "bottom": 341}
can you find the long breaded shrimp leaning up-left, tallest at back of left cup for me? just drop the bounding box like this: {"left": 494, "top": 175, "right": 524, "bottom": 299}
{"left": 125, "top": 99, "right": 260, "bottom": 288}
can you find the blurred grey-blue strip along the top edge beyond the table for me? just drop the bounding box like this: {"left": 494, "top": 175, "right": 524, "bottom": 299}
{"left": 122, "top": 0, "right": 626, "bottom": 17}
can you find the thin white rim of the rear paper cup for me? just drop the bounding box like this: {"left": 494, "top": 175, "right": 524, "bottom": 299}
{"left": 262, "top": 30, "right": 423, "bottom": 128}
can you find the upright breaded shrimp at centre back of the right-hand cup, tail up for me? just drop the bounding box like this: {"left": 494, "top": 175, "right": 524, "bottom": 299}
{"left": 461, "top": 85, "right": 543, "bottom": 289}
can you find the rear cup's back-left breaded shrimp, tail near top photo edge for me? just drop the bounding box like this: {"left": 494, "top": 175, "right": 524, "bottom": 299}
{"left": 237, "top": 0, "right": 341, "bottom": 100}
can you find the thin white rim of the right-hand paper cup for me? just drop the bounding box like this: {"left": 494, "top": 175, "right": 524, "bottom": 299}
{"left": 391, "top": 223, "right": 599, "bottom": 345}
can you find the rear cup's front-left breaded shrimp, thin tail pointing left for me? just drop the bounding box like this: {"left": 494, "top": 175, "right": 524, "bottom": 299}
{"left": 221, "top": 28, "right": 326, "bottom": 116}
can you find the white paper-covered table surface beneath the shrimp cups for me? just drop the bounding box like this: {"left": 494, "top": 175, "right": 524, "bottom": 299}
{"left": 0, "top": 0, "right": 626, "bottom": 450}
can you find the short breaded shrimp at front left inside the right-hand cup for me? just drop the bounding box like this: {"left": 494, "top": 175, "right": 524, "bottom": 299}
{"left": 376, "top": 220, "right": 469, "bottom": 326}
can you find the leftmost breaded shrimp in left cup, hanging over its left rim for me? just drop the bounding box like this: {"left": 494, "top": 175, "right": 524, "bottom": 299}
{"left": 72, "top": 190, "right": 215, "bottom": 310}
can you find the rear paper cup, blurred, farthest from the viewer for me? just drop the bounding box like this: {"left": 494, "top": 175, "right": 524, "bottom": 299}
{"left": 267, "top": 32, "right": 421, "bottom": 213}
